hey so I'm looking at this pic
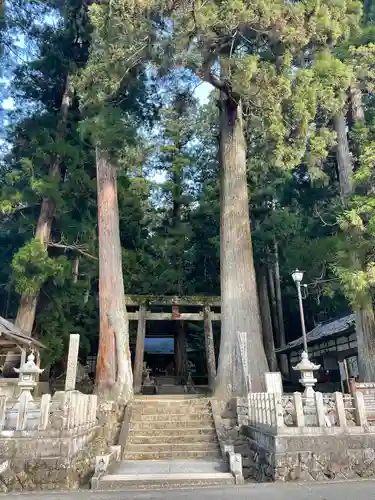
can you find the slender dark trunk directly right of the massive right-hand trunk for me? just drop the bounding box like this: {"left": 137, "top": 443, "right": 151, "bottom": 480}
{"left": 257, "top": 266, "right": 277, "bottom": 372}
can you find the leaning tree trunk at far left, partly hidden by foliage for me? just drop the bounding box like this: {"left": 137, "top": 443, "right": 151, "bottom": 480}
{"left": 15, "top": 75, "right": 73, "bottom": 335}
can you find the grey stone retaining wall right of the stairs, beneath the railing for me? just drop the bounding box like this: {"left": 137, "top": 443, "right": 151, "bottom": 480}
{"left": 242, "top": 426, "right": 375, "bottom": 482}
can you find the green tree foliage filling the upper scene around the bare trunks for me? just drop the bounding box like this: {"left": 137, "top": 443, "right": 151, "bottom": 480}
{"left": 0, "top": 0, "right": 375, "bottom": 370}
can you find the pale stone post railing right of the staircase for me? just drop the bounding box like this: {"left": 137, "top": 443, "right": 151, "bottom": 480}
{"left": 241, "top": 392, "right": 375, "bottom": 432}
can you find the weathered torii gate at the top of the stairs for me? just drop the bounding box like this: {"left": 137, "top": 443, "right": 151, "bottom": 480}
{"left": 125, "top": 295, "right": 221, "bottom": 394}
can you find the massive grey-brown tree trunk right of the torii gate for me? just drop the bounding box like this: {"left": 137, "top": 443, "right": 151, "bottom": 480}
{"left": 215, "top": 91, "right": 268, "bottom": 400}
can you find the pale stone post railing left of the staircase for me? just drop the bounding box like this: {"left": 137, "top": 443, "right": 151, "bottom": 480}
{"left": 0, "top": 391, "right": 97, "bottom": 435}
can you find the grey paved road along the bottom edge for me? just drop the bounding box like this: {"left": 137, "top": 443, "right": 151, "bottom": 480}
{"left": 0, "top": 481, "right": 375, "bottom": 500}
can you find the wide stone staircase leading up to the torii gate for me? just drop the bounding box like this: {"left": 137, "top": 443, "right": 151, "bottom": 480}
{"left": 93, "top": 395, "right": 234, "bottom": 490}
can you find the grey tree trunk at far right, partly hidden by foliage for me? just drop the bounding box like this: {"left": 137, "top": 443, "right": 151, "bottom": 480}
{"left": 333, "top": 111, "right": 375, "bottom": 382}
